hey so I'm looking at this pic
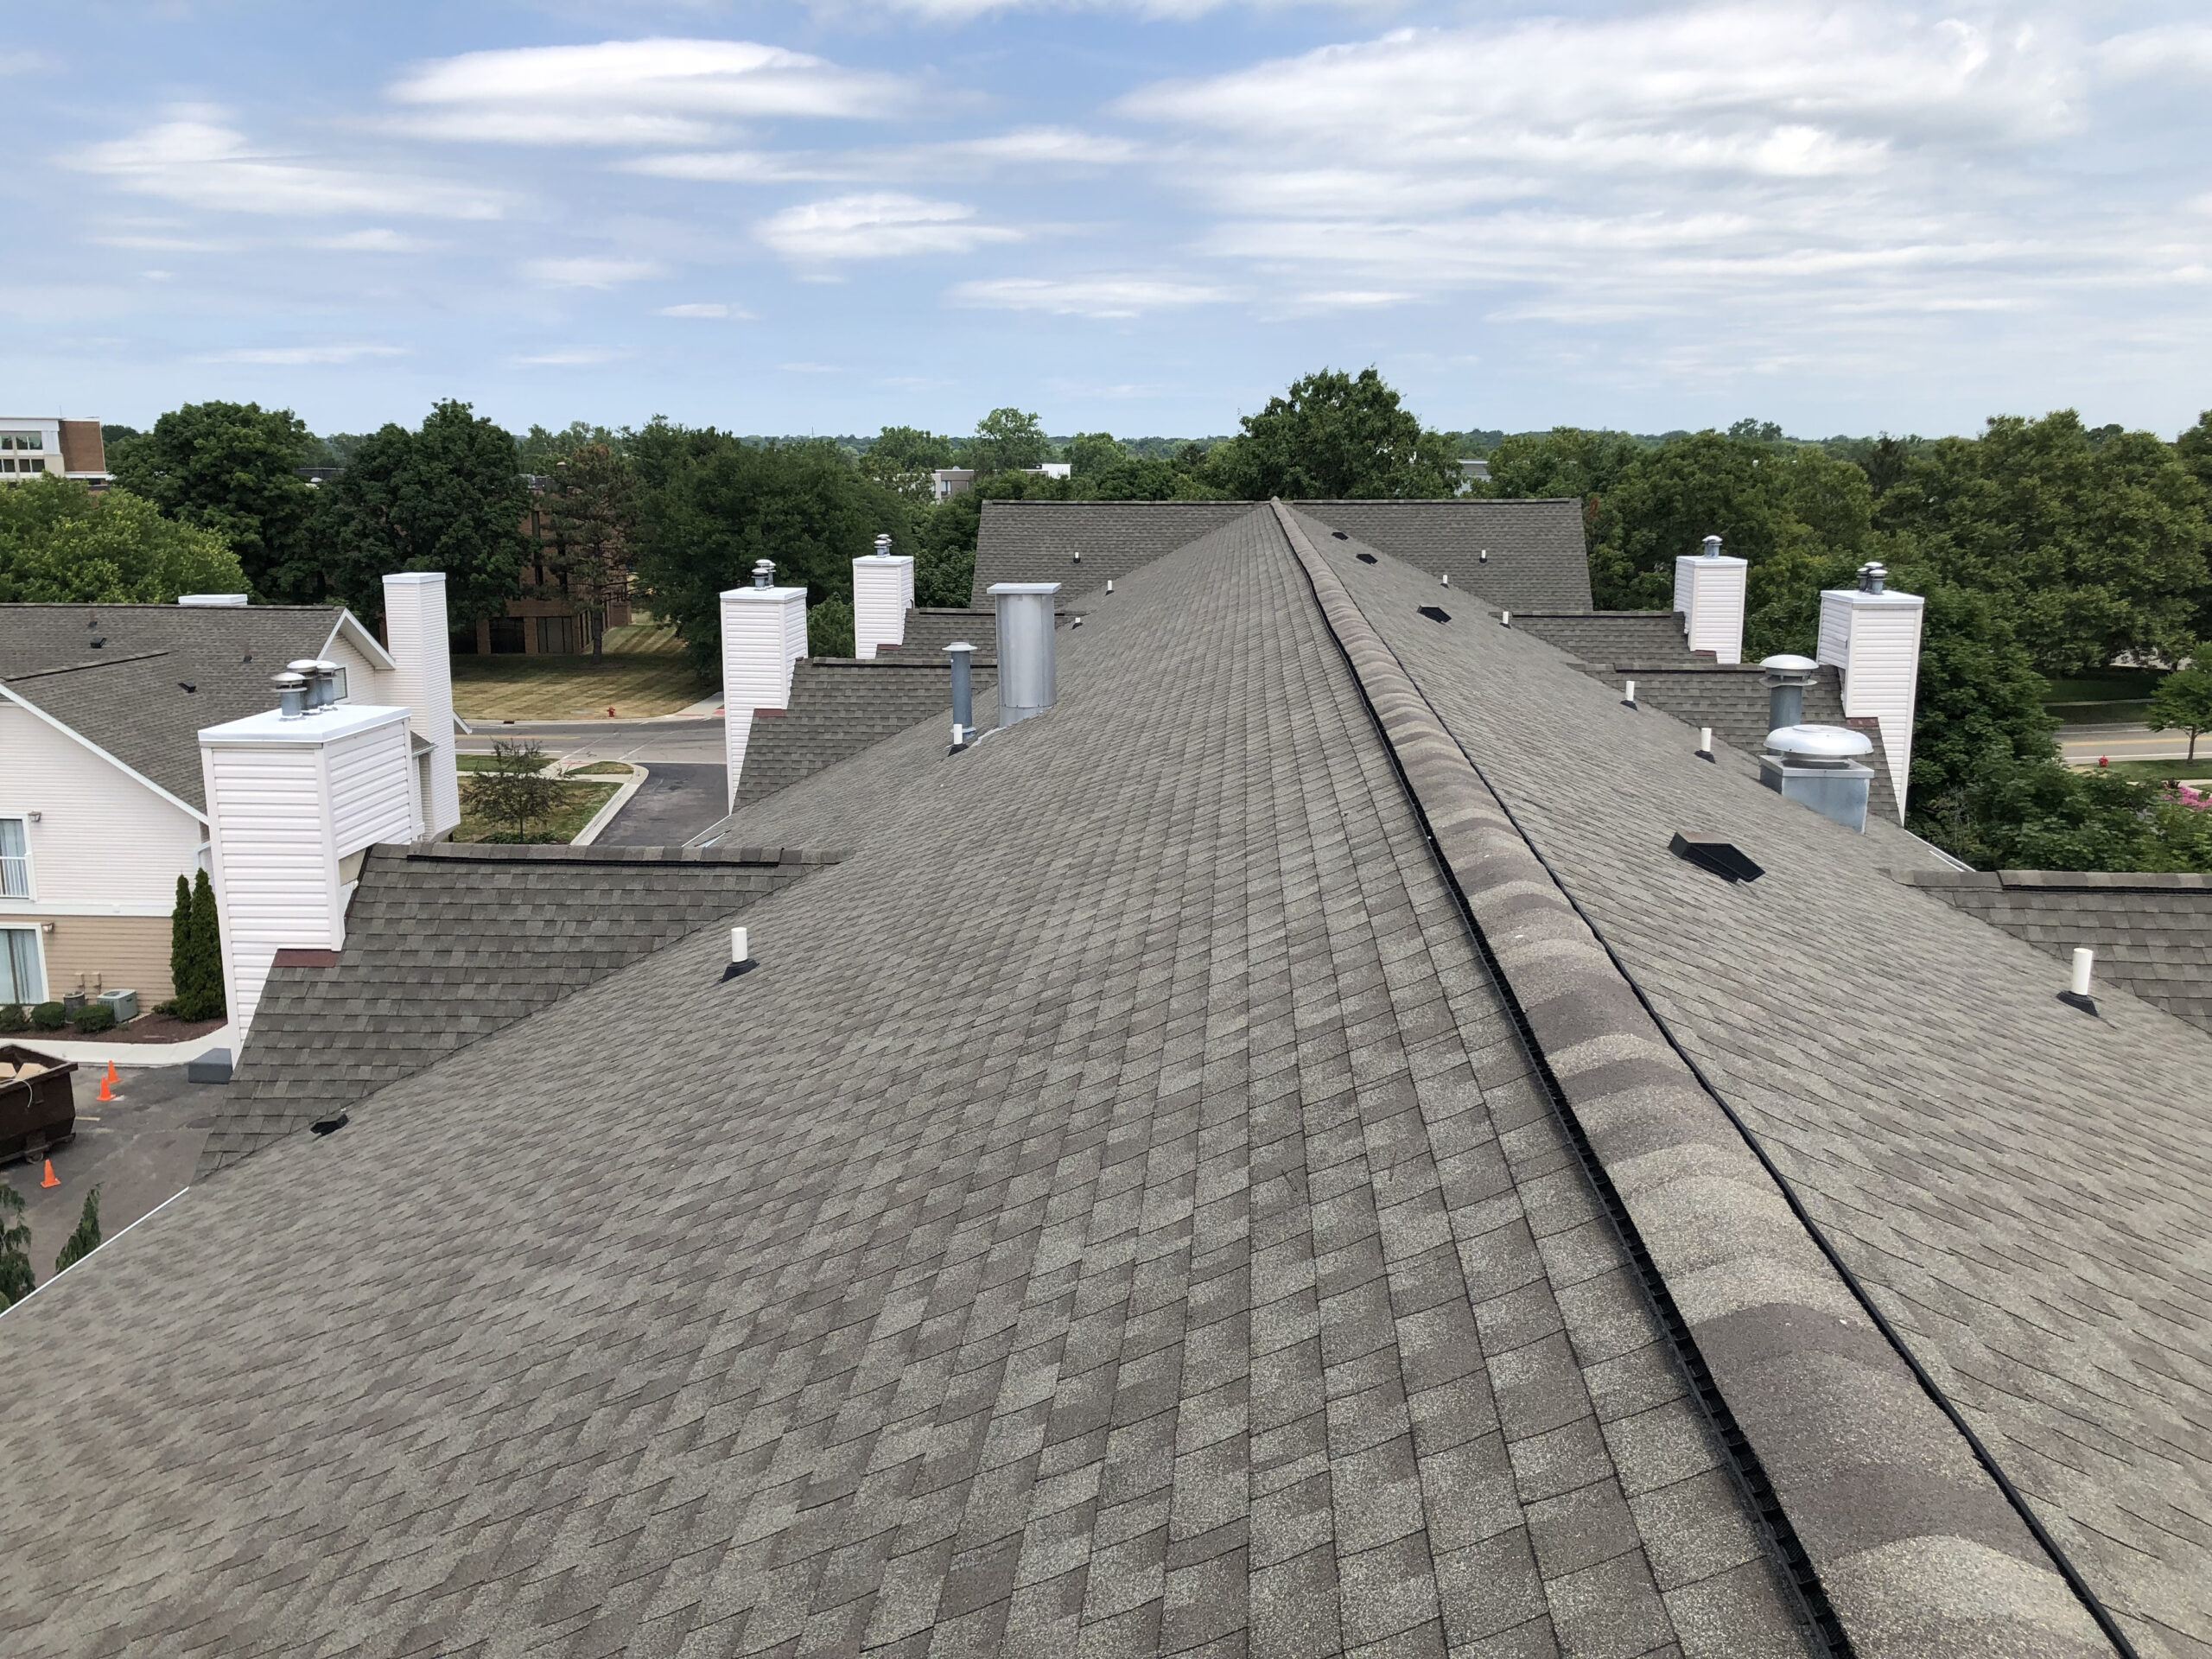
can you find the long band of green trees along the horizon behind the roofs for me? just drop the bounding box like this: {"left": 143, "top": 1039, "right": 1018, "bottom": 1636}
{"left": 26, "top": 367, "right": 2212, "bottom": 869}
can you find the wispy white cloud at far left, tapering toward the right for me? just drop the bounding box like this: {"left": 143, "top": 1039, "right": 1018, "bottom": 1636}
{"left": 62, "top": 108, "right": 500, "bottom": 219}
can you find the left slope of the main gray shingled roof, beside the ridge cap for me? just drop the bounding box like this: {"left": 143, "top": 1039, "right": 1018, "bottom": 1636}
{"left": 0, "top": 513, "right": 1801, "bottom": 1659}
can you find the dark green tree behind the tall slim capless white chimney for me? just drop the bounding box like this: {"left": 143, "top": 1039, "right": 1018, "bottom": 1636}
{"left": 315, "top": 400, "right": 533, "bottom": 626}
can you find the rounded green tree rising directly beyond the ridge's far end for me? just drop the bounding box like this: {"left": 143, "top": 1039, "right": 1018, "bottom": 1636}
{"left": 1208, "top": 367, "right": 1460, "bottom": 500}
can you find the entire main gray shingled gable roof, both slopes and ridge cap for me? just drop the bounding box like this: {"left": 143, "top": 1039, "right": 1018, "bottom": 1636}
{"left": 0, "top": 509, "right": 2212, "bottom": 1659}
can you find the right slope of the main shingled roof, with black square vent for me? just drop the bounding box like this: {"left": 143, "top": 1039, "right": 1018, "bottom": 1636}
{"left": 1323, "top": 512, "right": 2212, "bottom": 1655}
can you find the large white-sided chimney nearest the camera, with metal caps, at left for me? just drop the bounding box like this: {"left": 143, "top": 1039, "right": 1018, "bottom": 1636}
{"left": 199, "top": 703, "right": 423, "bottom": 1042}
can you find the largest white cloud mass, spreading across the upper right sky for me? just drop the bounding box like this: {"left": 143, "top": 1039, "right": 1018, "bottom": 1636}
{"left": 1117, "top": 3, "right": 2128, "bottom": 332}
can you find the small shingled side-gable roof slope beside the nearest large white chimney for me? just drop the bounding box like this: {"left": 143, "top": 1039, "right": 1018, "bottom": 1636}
{"left": 199, "top": 842, "right": 823, "bottom": 1177}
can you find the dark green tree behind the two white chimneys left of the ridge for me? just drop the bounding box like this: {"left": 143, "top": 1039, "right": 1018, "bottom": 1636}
{"left": 631, "top": 420, "right": 919, "bottom": 672}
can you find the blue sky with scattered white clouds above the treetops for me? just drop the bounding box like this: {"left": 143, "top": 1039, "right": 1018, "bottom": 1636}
{"left": 17, "top": 0, "right": 2212, "bottom": 435}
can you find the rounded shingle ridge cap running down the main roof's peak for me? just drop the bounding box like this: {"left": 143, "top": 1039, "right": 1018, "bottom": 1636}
{"left": 1276, "top": 506, "right": 2113, "bottom": 1659}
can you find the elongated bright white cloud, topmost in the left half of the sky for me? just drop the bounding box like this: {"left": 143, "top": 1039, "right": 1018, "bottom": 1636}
{"left": 391, "top": 40, "right": 907, "bottom": 146}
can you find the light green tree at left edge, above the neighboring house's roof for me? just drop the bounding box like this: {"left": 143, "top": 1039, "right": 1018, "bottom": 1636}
{"left": 0, "top": 474, "right": 245, "bottom": 604}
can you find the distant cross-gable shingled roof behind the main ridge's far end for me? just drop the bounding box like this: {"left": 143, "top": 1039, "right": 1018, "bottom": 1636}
{"left": 973, "top": 498, "right": 1591, "bottom": 611}
